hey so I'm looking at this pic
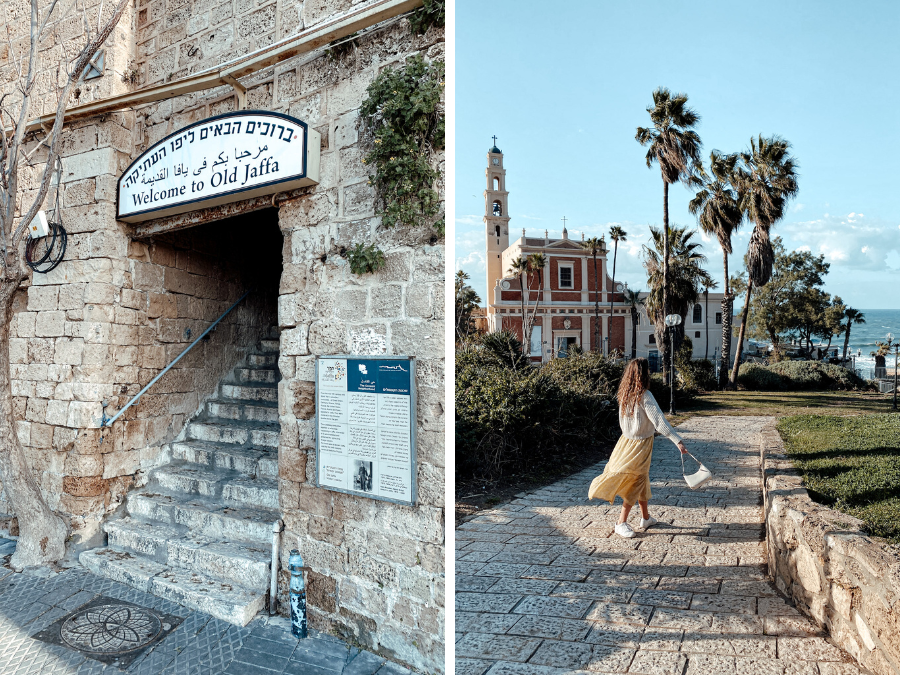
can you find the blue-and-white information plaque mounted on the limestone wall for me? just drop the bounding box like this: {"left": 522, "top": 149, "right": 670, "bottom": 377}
{"left": 316, "top": 356, "right": 416, "bottom": 505}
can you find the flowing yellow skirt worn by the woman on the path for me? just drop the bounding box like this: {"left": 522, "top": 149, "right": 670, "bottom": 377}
{"left": 588, "top": 436, "right": 653, "bottom": 504}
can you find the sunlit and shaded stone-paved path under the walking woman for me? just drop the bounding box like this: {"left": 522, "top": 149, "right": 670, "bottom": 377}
{"left": 456, "top": 417, "right": 865, "bottom": 675}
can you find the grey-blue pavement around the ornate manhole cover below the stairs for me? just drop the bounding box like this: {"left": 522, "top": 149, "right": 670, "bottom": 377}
{"left": 0, "top": 539, "right": 411, "bottom": 675}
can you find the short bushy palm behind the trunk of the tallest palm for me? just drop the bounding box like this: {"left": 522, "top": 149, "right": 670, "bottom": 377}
{"left": 644, "top": 226, "right": 712, "bottom": 362}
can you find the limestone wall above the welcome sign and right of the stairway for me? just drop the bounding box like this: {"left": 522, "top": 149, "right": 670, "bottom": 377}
{"left": 126, "top": 9, "right": 446, "bottom": 672}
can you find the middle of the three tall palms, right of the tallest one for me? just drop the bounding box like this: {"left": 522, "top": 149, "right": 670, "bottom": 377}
{"left": 688, "top": 150, "right": 744, "bottom": 389}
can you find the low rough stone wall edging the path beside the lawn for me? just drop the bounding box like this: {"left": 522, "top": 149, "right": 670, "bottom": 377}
{"left": 760, "top": 426, "right": 900, "bottom": 675}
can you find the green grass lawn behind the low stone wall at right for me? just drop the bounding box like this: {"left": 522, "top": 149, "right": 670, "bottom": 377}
{"left": 778, "top": 413, "right": 900, "bottom": 544}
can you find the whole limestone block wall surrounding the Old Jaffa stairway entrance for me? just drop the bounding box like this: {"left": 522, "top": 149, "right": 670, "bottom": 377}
{"left": 0, "top": 0, "right": 445, "bottom": 672}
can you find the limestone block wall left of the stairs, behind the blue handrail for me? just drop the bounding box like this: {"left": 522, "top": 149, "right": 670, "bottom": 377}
{"left": 0, "top": 115, "right": 281, "bottom": 553}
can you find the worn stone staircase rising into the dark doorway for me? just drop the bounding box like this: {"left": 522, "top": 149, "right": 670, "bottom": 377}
{"left": 79, "top": 329, "right": 281, "bottom": 626}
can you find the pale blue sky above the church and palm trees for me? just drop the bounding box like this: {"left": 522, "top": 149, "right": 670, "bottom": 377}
{"left": 455, "top": 0, "right": 900, "bottom": 309}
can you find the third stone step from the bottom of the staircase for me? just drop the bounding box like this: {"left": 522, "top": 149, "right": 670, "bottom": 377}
{"left": 125, "top": 490, "right": 281, "bottom": 546}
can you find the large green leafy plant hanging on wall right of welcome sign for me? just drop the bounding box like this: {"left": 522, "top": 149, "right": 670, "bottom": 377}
{"left": 360, "top": 56, "right": 444, "bottom": 234}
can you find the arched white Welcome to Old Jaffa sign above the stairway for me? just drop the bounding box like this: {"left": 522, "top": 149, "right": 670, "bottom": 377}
{"left": 118, "top": 110, "right": 321, "bottom": 223}
